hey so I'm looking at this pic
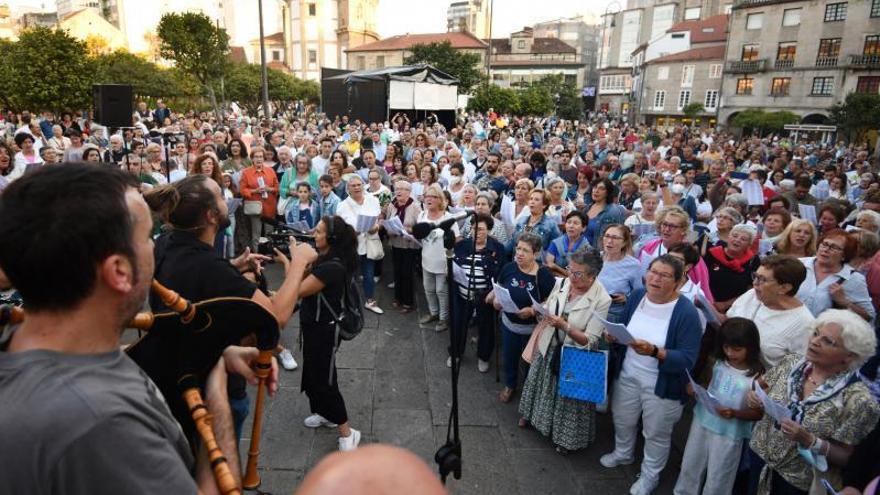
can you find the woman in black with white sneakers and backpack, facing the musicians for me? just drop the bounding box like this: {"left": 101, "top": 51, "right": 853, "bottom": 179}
{"left": 299, "top": 216, "right": 361, "bottom": 451}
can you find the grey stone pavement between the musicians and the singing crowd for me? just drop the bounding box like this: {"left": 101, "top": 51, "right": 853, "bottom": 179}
{"left": 241, "top": 268, "right": 688, "bottom": 495}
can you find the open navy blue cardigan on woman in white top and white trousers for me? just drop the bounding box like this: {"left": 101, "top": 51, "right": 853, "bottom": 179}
{"left": 615, "top": 289, "right": 703, "bottom": 403}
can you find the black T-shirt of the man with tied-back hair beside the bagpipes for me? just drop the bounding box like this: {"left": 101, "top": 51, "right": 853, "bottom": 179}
{"left": 150, "top": 231, "right": 257, "bottom": 399}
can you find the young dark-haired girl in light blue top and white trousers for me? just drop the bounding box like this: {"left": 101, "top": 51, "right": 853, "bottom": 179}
{"left": 674, "top": 318, "right": 764, "bottom": 495}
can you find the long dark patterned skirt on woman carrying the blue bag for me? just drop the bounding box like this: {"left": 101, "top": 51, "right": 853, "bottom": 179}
{"left": 519, "top": 340, "right": 596, "bottom": 450}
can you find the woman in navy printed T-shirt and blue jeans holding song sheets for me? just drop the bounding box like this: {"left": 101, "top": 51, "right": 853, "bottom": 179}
{"left": 486, "top": 232, "right": 555, "bottom": 403}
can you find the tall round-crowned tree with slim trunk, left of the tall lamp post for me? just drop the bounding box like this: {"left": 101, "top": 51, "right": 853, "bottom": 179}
{"left": 156, "top": 12, "right": 229, "bottom": 119}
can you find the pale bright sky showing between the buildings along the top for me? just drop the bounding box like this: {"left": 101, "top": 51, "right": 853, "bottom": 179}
{"left": 10, "top": 0, "right": 611, "bottom": 38}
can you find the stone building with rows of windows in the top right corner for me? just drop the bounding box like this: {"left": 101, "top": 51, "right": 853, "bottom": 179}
{"left": 719, "top": 0, "right": 880, "bottom": 124}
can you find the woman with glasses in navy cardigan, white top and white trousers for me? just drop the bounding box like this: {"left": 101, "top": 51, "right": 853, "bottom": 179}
{"left": 599, "top": 255, "right": 702, "bottom": 495}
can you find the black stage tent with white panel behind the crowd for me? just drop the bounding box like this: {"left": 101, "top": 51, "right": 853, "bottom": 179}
{"left": 321, "top": 64, "right": 458, "bottom": 127}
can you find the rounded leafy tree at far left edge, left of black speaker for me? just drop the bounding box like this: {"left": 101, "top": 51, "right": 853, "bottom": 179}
{"left": 0, "top": 27, "right": 94, "bottom": 111}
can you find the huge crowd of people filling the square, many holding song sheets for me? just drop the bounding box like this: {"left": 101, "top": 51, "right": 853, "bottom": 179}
{"left": 0, "top": 103, "right": 880, "bottom": 495}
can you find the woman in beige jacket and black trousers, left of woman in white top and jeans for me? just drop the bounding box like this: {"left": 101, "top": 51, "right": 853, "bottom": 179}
{"left": 385, "top": 180, "right": 422, "bottom": 313}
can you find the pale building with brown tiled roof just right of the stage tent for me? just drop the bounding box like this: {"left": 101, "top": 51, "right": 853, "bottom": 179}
{"left": 489, "top": 28, "right": 585, "bottom": 88}
